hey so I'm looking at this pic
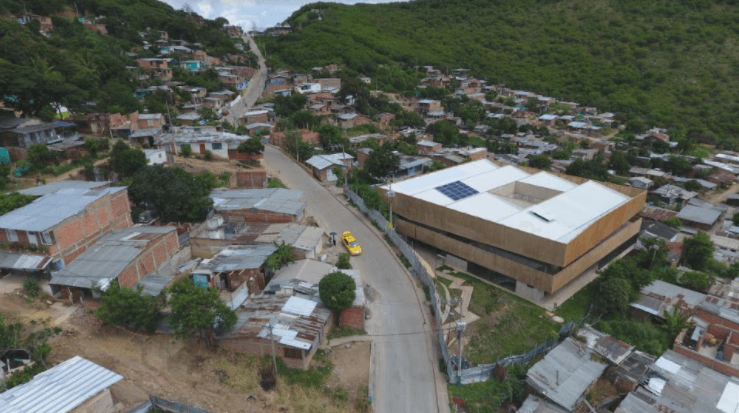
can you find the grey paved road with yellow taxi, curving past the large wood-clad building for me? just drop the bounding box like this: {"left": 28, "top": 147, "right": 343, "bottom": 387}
{"left": 264, "top": 146, "right": 449, "bottom": 413}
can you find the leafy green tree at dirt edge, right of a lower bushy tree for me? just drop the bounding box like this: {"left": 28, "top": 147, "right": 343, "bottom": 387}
{"left": 167, "top": 278, "right": 238, "bottom": 345}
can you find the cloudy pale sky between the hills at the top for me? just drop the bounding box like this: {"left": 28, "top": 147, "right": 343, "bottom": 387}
{"left": 163, "top": 0, "right": 410, "bottom": 30}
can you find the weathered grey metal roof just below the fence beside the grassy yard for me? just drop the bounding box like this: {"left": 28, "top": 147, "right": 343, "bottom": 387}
{"left": 526, "top": 338, "right": 607, "bottom": 411}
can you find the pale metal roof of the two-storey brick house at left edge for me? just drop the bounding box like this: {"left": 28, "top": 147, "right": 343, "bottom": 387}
{"left": 0, "top": 187, "right": 126, "bottom": 232}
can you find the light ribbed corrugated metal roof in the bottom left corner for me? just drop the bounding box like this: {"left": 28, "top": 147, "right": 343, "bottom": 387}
{"left": 0, "top": 356, "right": 123, "bottom": 413}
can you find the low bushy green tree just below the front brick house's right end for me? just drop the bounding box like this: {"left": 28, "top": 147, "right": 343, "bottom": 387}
{"left": 96, "top": 282, "right": 164, "bottom": 333}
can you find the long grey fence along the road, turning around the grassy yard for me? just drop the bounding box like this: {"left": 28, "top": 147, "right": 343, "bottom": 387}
{"left": 346, "top": 189, "right": 575, "bottom": 384}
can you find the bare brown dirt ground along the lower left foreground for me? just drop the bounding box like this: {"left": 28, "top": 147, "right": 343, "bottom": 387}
{"left": 0, "top": 294, "right": 369, "bottom": 413}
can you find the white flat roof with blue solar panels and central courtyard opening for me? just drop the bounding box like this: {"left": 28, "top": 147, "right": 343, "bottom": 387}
{"left": 384, "top": 159, "right": 630, "bottom": 244}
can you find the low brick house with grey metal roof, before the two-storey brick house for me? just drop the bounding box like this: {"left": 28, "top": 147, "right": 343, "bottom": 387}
{"left": 49, "top": 225, "right": 181, "bottom": 302}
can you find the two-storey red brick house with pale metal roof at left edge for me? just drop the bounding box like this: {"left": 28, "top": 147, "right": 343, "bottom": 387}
{"left": 0, "top": 181, "right": 132, "bottom": 272}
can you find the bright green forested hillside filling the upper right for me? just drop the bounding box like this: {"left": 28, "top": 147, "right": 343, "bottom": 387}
{"left": 266, "top": 0, "right": 739, "bottom": 149}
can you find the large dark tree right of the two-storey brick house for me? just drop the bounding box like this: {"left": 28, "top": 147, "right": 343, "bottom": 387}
{"left": 128, "top": 165, "right": 213, "bottom": 222}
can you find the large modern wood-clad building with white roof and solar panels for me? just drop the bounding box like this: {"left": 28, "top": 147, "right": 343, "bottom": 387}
{"left": 380, "top": 160, "right": 646, "bottom": 301}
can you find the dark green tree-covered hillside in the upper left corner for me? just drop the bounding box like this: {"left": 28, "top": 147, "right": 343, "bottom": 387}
{"left": 0, "top": 0, "right": 244, "bottom": 119}
